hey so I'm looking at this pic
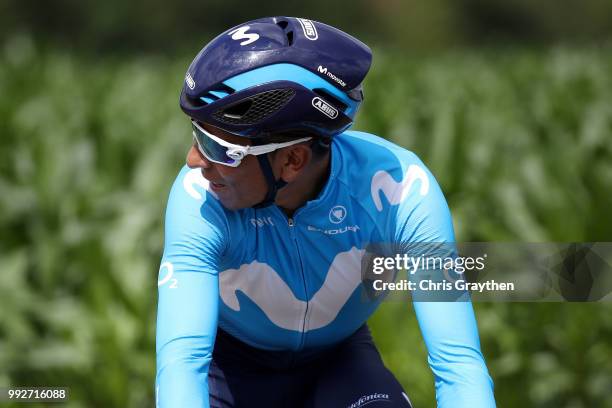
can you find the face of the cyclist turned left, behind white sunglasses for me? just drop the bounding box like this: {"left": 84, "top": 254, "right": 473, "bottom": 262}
{"left": 187, "top": 125, "right": 268, "bottom": 210}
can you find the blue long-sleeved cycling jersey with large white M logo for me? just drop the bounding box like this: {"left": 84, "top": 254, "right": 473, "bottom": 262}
{"left": 156, "top": 131, "right": 495, "bottom": 408}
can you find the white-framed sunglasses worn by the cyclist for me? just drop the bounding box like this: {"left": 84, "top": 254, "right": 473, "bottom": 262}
{"left": 191, "top": 120, "right": 312, "bottom": 167}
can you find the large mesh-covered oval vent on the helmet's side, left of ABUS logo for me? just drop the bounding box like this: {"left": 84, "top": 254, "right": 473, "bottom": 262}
{"left": 213, "top": 88, "right": 295, "bottom": 125}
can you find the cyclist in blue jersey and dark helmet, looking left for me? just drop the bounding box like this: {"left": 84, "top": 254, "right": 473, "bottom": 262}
{"left": 156, "top": 17, "right": 495, "bottom": 408}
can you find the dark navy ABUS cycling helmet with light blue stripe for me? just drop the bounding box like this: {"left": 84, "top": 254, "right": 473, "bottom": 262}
{"left": 180, "top": 17, "right": 372, "bottom": 139}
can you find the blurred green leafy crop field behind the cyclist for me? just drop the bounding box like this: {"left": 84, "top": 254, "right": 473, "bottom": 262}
{"left": 0, "top": 37, "right": 612, "bottom": 408}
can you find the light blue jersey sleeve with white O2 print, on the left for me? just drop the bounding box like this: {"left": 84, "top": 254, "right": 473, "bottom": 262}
{"left": 155, "top": 168, "right": 228, "bottom": 408}
